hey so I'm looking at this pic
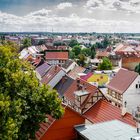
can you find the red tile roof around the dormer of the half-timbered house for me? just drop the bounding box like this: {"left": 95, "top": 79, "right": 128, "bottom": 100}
{"left": 64, "top": 79, "right": 98, "bottom": 102}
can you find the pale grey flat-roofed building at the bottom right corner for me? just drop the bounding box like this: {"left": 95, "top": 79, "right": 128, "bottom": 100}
{"left": 75, "top": 120, "right": 140, "bottom": 140}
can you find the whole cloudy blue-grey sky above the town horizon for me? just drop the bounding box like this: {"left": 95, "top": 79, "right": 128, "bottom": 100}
{"left": 0, "top": 0, "right": 140, "bottom": 33}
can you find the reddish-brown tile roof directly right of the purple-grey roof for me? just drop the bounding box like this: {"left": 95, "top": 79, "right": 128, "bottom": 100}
{"left": 41, "top": 66, "right": 62, "bottom": 84}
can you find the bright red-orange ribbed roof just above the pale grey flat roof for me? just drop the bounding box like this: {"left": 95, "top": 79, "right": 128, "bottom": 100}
{"left": 84, "top": 99, "right": 136, "bottom": 126}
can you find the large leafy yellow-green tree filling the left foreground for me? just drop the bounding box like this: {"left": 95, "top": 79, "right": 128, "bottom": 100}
{"left": 0, "top": 46, "right": 64, "bottom": 140}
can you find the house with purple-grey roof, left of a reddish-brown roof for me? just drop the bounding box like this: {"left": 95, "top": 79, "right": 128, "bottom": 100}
{"left": 35, "top": 62, "right": 51, "bottom": 80}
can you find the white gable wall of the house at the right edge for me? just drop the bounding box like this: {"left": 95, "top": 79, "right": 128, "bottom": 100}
{"left": 123, "top": 76, "right": 140, "bottom": 113}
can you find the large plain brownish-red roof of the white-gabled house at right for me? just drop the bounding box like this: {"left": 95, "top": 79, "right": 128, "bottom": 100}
{"left": 107, "top": 69, "right": 138, "bottom": 94}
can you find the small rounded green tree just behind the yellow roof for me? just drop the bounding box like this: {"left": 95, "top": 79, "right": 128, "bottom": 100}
{"left": 98, "top": 57, "right": 112, "bottom": 70}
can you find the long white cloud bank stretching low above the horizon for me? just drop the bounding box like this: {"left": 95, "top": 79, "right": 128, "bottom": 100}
{"left": 0, "top": 9, "right": 140, "bottom": 32}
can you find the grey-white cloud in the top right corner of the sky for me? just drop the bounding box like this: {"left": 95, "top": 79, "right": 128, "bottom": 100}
{"left": 84, "top": 0, "right": 140, "bottom": 13}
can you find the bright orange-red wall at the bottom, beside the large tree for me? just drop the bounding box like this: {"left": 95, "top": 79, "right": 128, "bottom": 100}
{"left": 41, "top": 108, "right": 85, "bottom": 140}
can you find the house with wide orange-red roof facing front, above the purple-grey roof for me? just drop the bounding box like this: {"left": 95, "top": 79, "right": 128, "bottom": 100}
{"left": 45, "top": 51, "right": 69, "bottom": 66}
